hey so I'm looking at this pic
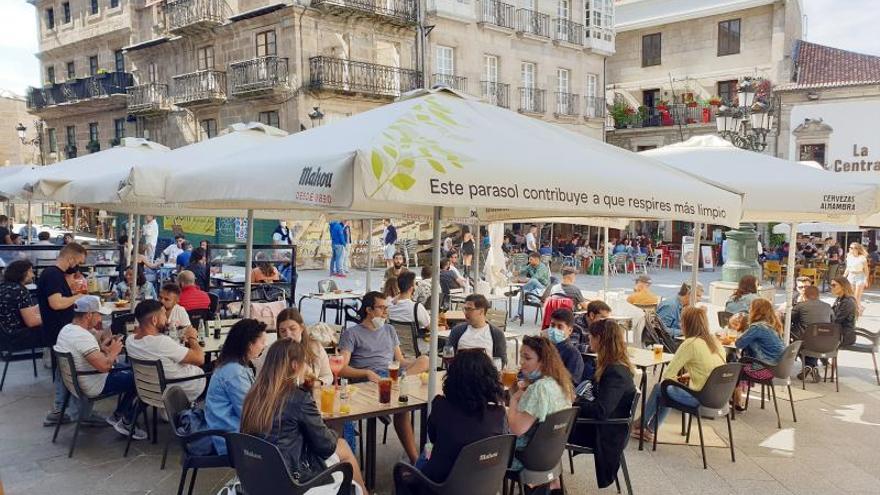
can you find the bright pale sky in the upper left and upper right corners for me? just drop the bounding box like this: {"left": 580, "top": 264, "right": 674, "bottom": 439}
{"left": 0, "top": 0, "right": 880, "bottom": 94}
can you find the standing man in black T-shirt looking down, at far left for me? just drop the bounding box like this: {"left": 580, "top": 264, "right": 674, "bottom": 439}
{"left": 37, "top": 242, "right": 86, "bottom": 426}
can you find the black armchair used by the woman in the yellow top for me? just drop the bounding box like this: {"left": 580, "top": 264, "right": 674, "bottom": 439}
{"left": 654, "top": 363, "right": 742, "bottom": 469}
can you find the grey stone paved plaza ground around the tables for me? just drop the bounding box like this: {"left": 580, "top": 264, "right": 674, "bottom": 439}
{"left": 0, "top": 269, "right": 880, "bottom": 495}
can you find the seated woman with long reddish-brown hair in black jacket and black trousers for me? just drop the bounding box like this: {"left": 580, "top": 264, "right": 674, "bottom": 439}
{"left": 569, "top": 320, "right": 636, "bottom": 488}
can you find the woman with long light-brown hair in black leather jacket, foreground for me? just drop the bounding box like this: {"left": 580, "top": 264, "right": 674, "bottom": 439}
{"left": 241, "top": 339, "right": 366, "bottom": 493}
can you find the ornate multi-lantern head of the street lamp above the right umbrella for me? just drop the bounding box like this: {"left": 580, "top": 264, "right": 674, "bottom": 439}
{"left": 715, "top": 78, "right": 776, "bottom": 152}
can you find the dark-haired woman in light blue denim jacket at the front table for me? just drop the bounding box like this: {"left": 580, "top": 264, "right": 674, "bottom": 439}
{"left": 205, "top": 319, "right": 266, "bottom": 455}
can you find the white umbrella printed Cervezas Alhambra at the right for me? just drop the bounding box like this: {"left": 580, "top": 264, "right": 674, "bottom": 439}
{"left": 641, "top": 135, "right": 878, "bottom": 342}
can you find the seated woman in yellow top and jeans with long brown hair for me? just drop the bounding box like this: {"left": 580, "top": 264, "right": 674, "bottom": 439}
{"left": 633, "top": 306, "right": 727, "bottom": 442}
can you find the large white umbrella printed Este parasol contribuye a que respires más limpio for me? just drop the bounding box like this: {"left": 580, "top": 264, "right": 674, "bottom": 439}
{"left": 158, "top": 89, "right": 741, "bottom": 404}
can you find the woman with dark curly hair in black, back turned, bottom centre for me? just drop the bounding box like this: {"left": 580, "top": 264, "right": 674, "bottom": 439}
{"left": 416, "top": 349, "right": 507, "bottom": 483}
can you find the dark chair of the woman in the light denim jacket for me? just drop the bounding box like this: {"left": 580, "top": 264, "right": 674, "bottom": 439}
{"left": 162, "top": 385, "right": 232, "bottom": 495}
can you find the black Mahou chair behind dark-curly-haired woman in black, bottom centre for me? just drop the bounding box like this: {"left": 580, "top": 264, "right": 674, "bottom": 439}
{"left": 394, "top": 435, "right": 516, "bottom": 495}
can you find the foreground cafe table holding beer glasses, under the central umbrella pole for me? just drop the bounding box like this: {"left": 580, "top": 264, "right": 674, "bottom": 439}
{"left": 315, "top": 376, "right": 428, "bottom": 490}
